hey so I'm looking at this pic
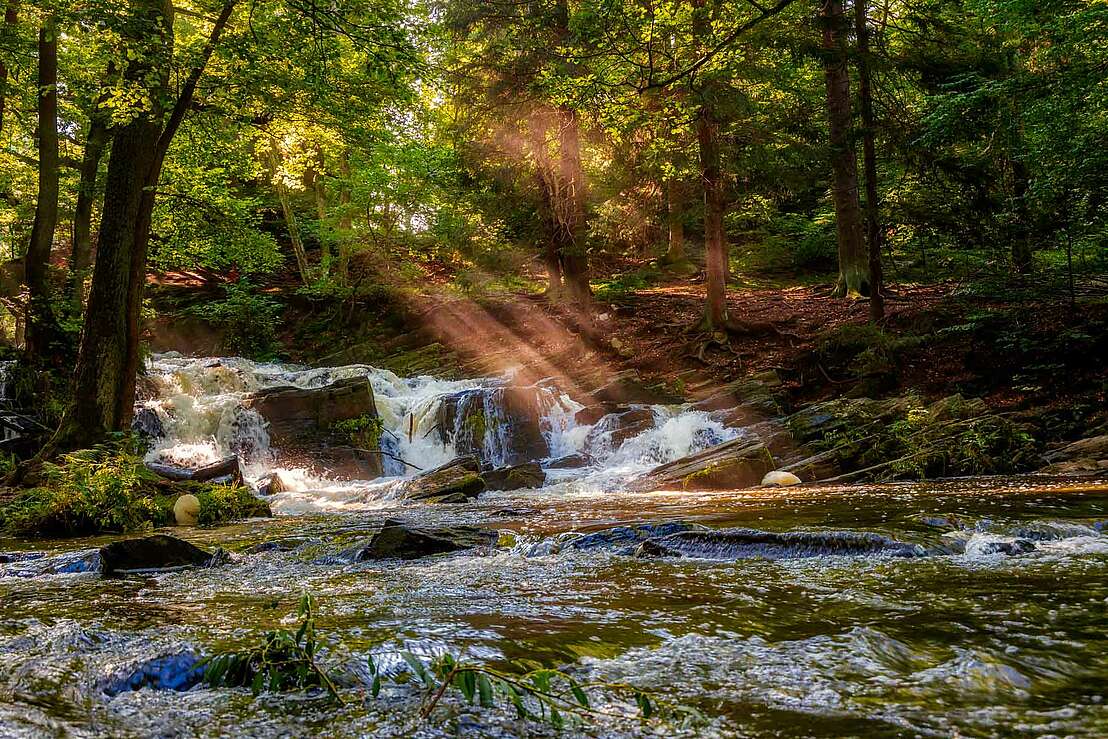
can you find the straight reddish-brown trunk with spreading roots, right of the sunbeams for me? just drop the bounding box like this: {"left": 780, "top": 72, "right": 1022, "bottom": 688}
{"left": 696, "top": 104, "right": 728, "bottom": 330}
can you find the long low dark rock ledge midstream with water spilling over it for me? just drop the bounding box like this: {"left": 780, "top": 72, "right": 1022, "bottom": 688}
{"left": 637, "top": 528, "right": 926, "bottom": 560}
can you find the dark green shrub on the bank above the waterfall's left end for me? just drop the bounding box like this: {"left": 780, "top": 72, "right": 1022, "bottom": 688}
{"left": 188, "top": 279, "right": 281, "bottom": 359}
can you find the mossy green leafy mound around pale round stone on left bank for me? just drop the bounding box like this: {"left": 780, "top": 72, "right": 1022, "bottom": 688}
{"left": 0, "top": 445, "right": 269, "bottom": 536}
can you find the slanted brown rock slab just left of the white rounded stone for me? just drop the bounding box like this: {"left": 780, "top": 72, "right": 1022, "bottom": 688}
{"left": 632, "top": 437, "right": 777, "bottom": 491}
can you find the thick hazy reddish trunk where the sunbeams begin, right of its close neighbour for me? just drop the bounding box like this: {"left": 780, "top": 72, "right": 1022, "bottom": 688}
{"left": 553, "top": 105, "right": 593, "bottom": 307}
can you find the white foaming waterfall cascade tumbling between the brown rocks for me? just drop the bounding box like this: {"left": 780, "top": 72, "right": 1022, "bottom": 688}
{"left": 136, "top": 353, "right": 742, "bottom": 513}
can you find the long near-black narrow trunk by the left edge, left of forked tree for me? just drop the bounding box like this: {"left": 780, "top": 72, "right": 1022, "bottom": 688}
{"left": 27, "top": 17, "right": 61, "bottom": 367}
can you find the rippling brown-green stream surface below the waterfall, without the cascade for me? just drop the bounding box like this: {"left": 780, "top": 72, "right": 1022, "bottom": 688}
{"left": 0, "top": 479, "right": 1108, "bottom": 736}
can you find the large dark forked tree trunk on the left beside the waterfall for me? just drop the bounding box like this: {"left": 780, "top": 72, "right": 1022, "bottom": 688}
{"left": 50, "top": 0, "right": 236, "bottom": 459}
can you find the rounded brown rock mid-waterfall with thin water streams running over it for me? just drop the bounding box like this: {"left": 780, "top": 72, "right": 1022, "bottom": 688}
{"left": 438, "top": 386, "right": 554, "bottom": 465}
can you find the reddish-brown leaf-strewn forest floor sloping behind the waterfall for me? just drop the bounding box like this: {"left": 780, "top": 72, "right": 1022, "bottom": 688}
{"left": 151, "top": 257, "right": 1108, "bottom": 445}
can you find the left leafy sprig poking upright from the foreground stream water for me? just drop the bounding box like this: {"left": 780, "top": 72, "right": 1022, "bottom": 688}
{"left": 202, "top": 593, "right": 342, "bottom": 702}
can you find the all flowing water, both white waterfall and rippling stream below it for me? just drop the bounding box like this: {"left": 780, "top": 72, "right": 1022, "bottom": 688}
{"left": 0, "top": 356, "right": 1108, "bottom": 737}
